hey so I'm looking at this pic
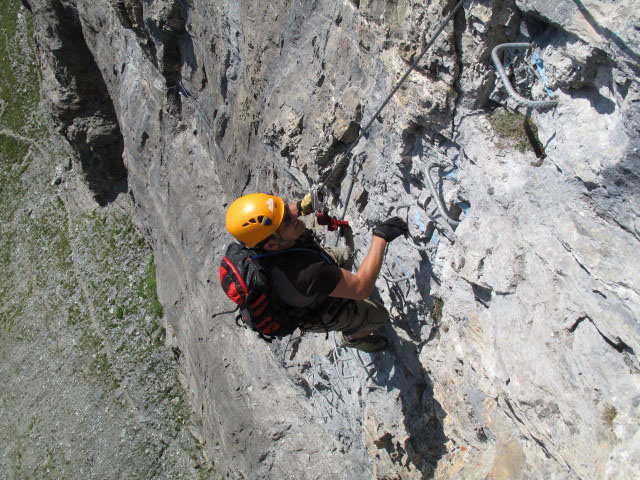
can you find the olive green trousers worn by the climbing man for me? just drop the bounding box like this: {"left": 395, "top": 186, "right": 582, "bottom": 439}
{"left": 304, "top": 247, "right": 389, "bottom": 335}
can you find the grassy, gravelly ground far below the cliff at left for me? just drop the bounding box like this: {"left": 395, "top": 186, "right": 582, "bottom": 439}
{"left": 0, "top": 2, "right": 206, "bottom": 478}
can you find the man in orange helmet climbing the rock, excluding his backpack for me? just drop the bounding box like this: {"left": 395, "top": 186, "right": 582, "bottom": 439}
{"left": 226, "top": 193, "right": 408, "bottom": 352}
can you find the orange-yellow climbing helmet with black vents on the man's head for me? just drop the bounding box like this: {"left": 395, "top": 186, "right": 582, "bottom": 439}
{"left": 227, "top": 193, "right": 284, "bottom": 248}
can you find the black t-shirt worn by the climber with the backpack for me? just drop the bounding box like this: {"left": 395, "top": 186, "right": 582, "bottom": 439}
{"left": 270, "top": 230, "right": 342, "bottom": 308}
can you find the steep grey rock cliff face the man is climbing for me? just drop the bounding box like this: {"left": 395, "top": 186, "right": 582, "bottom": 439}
{"left": 28, "top": 0, "right": 640, "bottom": 478}
